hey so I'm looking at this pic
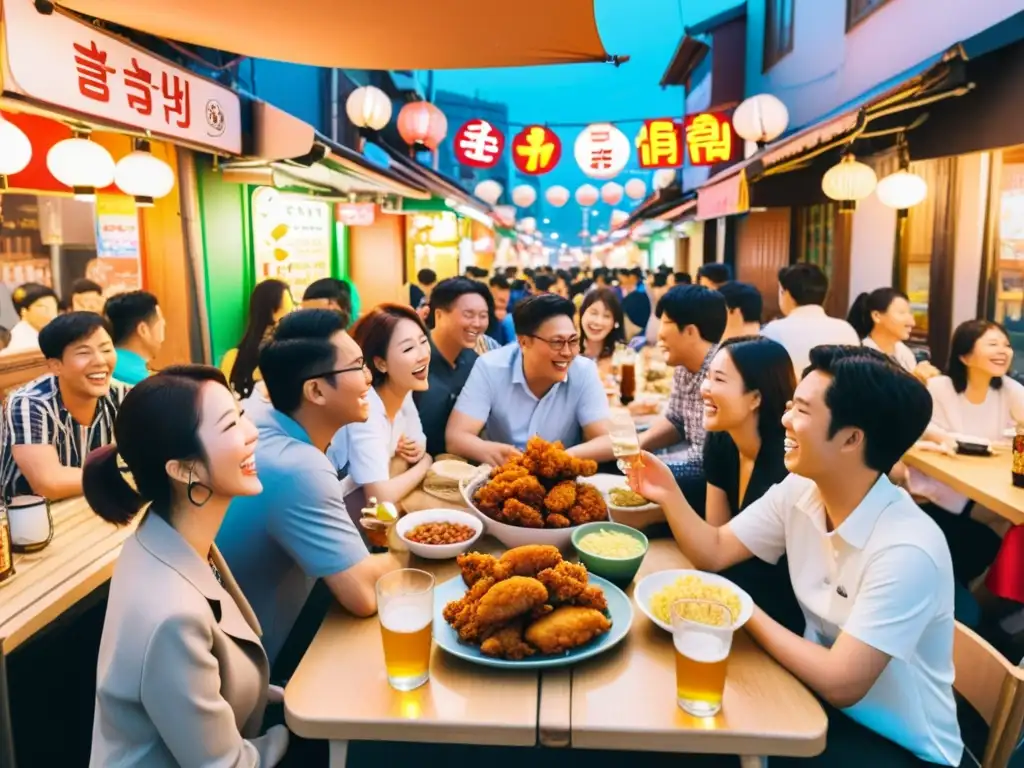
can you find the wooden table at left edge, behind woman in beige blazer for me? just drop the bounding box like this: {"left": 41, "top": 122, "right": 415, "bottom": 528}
{"left": 0, "top": 498, "right": 134, "bottom": 766}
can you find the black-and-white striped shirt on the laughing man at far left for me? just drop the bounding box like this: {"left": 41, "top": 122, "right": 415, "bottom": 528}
{"left": 0, "top": 376, "right": 128, "bottom": 497}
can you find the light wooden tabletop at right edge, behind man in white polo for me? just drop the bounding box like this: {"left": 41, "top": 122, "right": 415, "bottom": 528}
{"left": 903, "top": 449, "right": 1024, "bottom": 525}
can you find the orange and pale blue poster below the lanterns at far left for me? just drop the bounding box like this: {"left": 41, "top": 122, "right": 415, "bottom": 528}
{"left": 91, "top": 195, "right": 142, "bottom": 296}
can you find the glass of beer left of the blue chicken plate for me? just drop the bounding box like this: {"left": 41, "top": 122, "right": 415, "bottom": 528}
{"left": 377, "top": 568, "right": 434, "bottom": 691}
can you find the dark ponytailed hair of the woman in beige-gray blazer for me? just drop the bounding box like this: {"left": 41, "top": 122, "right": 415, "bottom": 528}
{"left": 82, "top": 366, "right": 227, "bottom": 525}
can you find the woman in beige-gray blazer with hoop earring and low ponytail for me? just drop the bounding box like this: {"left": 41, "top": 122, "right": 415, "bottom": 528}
{"left": 83, "top": 366, "right": 288, "bottom": 768}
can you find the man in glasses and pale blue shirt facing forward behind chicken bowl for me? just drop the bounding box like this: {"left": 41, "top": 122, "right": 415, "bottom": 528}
{"left": 445, "top": 294, "right": 611, "bottom": 466}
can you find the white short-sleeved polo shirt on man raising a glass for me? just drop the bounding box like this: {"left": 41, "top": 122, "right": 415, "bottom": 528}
{"left": 728, "top": 475, "right": 964, "bottom": 765}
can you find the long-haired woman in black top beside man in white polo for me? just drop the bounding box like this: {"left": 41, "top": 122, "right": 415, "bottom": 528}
{"left": 700, "top": 336, "right": 804, "bottom": 633}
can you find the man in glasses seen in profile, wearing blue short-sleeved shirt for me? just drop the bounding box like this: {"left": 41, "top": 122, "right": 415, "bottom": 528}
{"left": 217, "top": 309, "right": 398, "bottom": 665}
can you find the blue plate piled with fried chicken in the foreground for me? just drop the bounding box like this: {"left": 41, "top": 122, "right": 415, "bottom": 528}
{"left": 434, "top": 544, "right": 633, "bottom": 669}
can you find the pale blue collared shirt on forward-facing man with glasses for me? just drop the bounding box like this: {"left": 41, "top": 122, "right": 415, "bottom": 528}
{"left": 455, "top": 344, "right": 609, "bottom": 450}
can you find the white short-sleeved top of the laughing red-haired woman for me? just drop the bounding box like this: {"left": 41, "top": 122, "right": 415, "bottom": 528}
{"left": 327, "top": 388, "right": 427, "bottom": 485}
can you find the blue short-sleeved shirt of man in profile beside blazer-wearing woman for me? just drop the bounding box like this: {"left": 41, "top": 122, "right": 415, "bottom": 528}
{"left": 217, "top": 389, "right": 368, "bottom": 664}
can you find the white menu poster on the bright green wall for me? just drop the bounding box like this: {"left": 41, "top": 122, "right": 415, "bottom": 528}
{"left": 252, "top": 186, "right": 334, "bottom": 301}
